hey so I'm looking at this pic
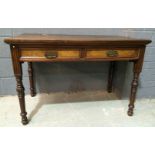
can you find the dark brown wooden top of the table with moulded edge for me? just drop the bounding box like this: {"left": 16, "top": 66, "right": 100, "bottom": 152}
{"left": 4, "top": 34, "right": 151, "bottom": 45}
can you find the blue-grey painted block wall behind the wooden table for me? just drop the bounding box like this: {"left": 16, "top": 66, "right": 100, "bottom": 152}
{"left": 0, "top": 28, "right": 155, "bottom": 98}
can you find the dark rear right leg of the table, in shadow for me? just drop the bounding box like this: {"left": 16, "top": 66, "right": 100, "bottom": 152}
{"left": 107, "top": 61, "right": 115, "bottom": 93}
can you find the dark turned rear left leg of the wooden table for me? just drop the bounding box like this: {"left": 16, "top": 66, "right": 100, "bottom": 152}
{"left": 28, "top": 62, "right": 36, "bottom": 97}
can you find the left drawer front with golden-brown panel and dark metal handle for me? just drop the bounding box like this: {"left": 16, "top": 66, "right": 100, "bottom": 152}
{"left": 21, "top": 49, "right": 80, "bottom": 60}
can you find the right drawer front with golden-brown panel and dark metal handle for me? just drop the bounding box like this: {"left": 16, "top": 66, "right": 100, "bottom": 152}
{"left": 86, "top": 49, "right": 139, "bottom": 59}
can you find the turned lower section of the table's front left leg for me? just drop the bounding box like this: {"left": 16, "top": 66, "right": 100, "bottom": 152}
{"left": 15, "top": 75, "right": 28, "bottom": 125}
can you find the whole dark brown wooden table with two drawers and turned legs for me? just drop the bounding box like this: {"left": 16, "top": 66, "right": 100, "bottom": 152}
{"left": 5, "top": 34, "right": 151, "bottom": 125}
